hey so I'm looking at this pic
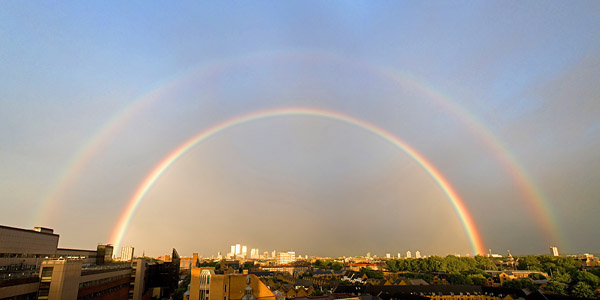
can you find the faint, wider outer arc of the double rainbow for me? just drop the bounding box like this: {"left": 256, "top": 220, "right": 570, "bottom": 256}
{"left": 32, "top": 49, "right": 562, "bottom": 253}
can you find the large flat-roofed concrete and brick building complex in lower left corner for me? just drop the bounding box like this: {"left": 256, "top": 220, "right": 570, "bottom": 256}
{"left": 0, "top": 226, "right": 179, "bottom": 300}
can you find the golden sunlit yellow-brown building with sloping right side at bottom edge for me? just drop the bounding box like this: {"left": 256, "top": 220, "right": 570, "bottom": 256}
{"left": 189, "top": 268, "right": 275, "bottom": 300}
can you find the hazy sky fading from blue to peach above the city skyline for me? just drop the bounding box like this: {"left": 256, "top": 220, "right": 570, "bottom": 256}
{"left": 0, "top": 1, "right": 600, "bottom": 256}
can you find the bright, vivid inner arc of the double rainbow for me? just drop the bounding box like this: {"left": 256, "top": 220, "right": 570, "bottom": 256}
{"left": 110, "top": 108, "right": 485, "bottom": 254}
